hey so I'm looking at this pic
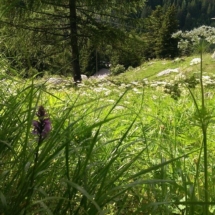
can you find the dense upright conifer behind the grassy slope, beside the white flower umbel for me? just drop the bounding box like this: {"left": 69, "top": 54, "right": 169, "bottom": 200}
{"left": 143, "top": 5, "right": 178, "bottom": 58}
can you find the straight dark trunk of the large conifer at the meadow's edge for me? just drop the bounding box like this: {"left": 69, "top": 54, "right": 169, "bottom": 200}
{"left": 69, "top": 0, "right": 81, "bottom": 83}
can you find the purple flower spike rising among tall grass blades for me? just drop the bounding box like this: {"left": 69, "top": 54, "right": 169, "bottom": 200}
{"left": 32, "top": 106, "right": 51, "bottom": 138}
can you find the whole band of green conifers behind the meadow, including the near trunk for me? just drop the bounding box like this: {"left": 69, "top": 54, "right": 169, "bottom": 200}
{"left": 0, "top": 0, "right": 215, "bottom": 82}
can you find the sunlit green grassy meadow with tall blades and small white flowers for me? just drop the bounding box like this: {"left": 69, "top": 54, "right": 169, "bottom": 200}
{"left": 0, "top": 54, "right": 215, "bottom": 215}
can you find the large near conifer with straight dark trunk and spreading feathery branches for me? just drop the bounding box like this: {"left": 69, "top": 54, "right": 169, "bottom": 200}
{"left": 0, "top": 0, "right": 145, "bottom": 82}
